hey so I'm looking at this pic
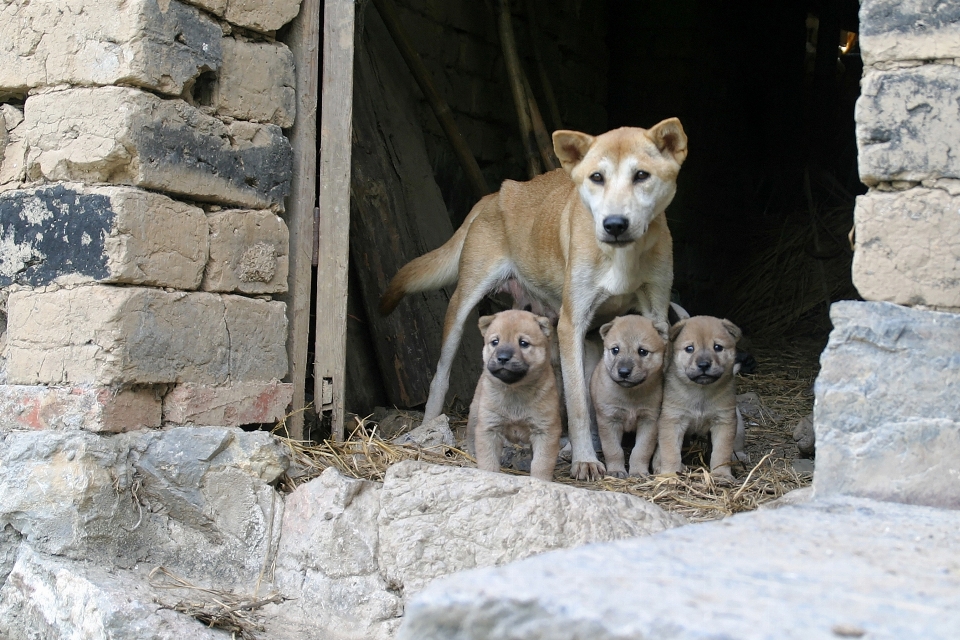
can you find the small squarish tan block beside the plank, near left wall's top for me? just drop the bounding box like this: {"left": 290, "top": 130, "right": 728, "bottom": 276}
{"left": 217, "top": 38, "right": 297, "bottom": 127}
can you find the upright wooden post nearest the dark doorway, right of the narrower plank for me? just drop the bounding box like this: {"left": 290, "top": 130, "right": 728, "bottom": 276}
{"left": 314, "top": 0, "right": 354, "bottom": 440}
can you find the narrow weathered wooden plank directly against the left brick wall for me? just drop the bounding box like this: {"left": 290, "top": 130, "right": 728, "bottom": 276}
{"left": 284, "top": 0, "right": 320, "bottom": 440}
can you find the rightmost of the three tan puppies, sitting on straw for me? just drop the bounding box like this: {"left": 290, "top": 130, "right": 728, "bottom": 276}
{"left": 657, "top": 316, "right": 741, "bottom": 480}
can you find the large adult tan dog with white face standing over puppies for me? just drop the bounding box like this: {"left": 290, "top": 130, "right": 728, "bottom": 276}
{"left": 380, "top": 118, "right": 687, "bottom": 479}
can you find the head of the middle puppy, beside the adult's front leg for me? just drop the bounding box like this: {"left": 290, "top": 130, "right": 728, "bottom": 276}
{"left": 600, "top": 315, "right": 664, "bottom": 388}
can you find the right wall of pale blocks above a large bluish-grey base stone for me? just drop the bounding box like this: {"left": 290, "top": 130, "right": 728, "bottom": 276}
{"left": 814, "top": 0, "right": 960, "bottom": 508}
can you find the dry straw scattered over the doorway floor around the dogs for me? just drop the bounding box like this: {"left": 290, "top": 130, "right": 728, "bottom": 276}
{"left": 278, "top": 340, "right": 822, "bottom": 522}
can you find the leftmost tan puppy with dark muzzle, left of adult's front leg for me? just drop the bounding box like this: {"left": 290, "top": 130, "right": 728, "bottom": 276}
{"left": 467, "top": 311, "right": 562, "bottom": 481}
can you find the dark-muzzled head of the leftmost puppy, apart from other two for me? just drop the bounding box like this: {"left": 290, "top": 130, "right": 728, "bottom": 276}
{"left": 480, "top": 310, "right": 553, "bottom": 384}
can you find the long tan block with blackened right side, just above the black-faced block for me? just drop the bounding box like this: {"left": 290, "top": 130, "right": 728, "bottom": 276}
{"left": 22, "top": 87, "right": 293, "bottom": 208}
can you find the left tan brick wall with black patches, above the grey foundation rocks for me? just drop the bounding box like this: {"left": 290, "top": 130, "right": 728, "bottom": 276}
{"left": 0, "top": 0, "right": 299, "bottom": 432}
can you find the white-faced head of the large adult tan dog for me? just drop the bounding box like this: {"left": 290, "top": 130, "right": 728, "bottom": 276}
{"left": 553, "top": 118, "right": 687, "bottom": 246}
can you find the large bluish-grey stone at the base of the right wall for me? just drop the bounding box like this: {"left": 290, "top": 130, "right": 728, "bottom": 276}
{"left": 814, "top": 302, "right": 960, "bottom": 509}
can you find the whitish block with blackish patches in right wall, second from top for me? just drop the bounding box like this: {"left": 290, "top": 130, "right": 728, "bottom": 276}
{"left": 856, "top": 64, "right": 960, "bottom": 186}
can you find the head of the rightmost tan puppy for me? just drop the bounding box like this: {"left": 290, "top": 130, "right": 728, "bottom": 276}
{"left": 670, "top": 316, "right": 742, "bottom": 385}
